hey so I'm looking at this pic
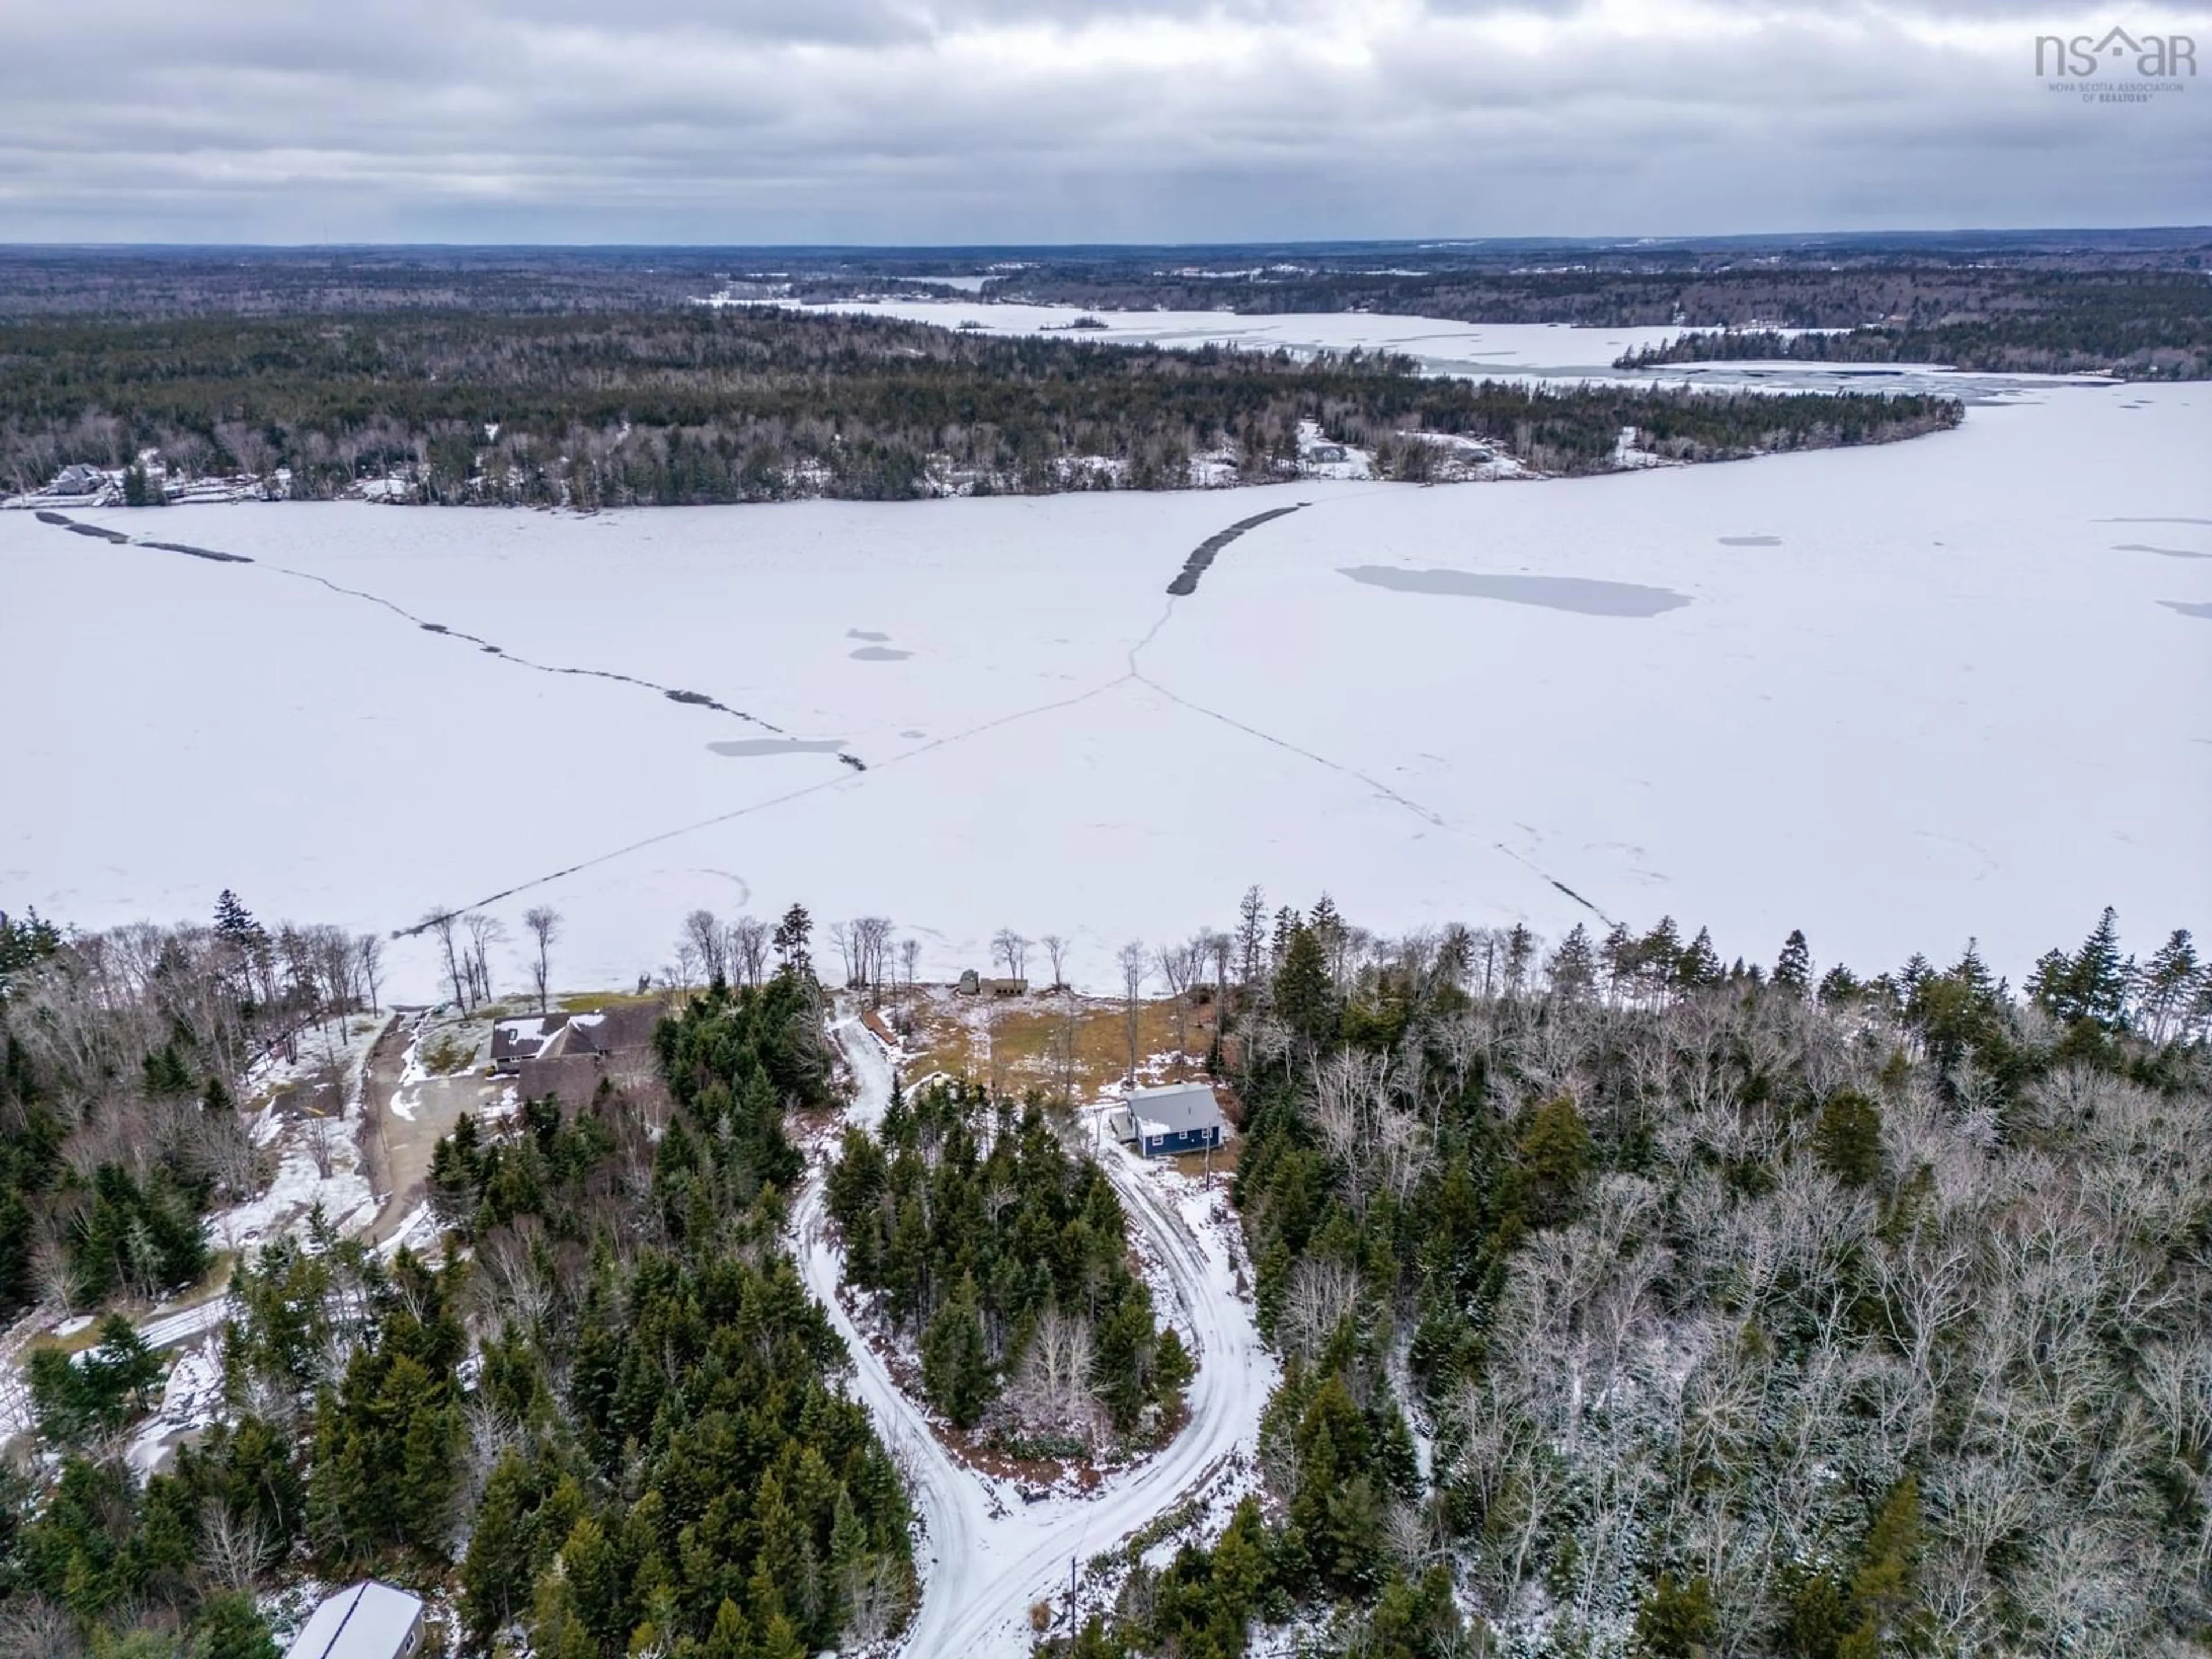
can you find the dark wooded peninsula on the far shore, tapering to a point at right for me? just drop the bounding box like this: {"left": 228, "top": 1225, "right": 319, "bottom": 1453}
{"left": 0, "top": 308, "right": 1957, "bottom": 509}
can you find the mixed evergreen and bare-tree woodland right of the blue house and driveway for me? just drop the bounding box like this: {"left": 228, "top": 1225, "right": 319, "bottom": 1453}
{"left": 1055, "top": 911, "right": 2212, "bottom": 1659}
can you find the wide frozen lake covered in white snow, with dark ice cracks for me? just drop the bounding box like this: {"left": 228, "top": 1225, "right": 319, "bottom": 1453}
{"left": 0, "top": 373, "right": 2212, "bottom": 995}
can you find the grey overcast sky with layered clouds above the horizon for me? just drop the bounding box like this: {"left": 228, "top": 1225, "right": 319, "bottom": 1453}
{"left": 0, "top": 0, "right": 2212, "bottom": 243}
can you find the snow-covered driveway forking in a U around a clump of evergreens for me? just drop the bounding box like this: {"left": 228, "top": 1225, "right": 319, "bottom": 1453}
{"left": 792, "top": 1017, "right": 1277, "bottom": 1659}
